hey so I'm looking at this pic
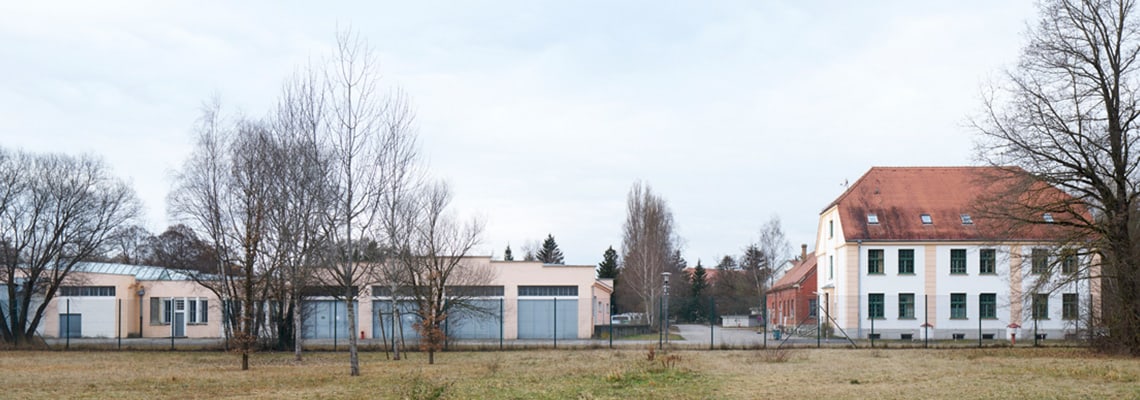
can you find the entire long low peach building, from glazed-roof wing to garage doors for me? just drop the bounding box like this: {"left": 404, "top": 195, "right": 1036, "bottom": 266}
{"left": 22, "top": 256, "right": 613, "bottom": 341}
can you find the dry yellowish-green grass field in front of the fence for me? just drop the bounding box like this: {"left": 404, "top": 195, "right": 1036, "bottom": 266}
{"left": 0, "top": 349, "right": 1140, "bottom": 400}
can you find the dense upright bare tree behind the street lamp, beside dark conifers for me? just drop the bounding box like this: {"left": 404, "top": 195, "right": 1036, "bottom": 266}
{"left": 619, "top": 182, "right": 678, "bottom": 326}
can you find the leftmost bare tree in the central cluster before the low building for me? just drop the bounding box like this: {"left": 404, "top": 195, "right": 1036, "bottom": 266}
{"left": 170, "top": 101, "right": 286, "bottom": 370}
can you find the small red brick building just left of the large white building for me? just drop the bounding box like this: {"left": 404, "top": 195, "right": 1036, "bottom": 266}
{"left": 767, "top": 245, "right": 819, "bottom": 328}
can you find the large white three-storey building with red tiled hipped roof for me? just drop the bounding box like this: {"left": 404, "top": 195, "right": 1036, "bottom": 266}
{"left": 815, "top": 168, "right": 1097, "bottom": 340}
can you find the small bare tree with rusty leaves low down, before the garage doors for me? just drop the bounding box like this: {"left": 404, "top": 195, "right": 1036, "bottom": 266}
{"left": 393, "top": 182, "right": 494, "bottom": 364}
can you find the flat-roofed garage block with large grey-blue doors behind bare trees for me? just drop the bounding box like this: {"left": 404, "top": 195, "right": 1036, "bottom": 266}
{"left": 303, "top": 256, "right": 613, "bottom": 341}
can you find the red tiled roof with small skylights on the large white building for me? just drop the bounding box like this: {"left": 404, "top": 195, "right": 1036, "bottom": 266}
{"left": 824, "top": 166, "right": 1086, "bottom": 242}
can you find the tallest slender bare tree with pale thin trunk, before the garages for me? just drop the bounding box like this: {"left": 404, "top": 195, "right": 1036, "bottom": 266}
{"left": 321, "top": 31, "right": 416, "bottom": 376}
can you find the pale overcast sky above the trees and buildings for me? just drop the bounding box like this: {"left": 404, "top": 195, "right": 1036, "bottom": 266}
{"left": 0, "top": 0, "right": 1036, "bottom": 267}
